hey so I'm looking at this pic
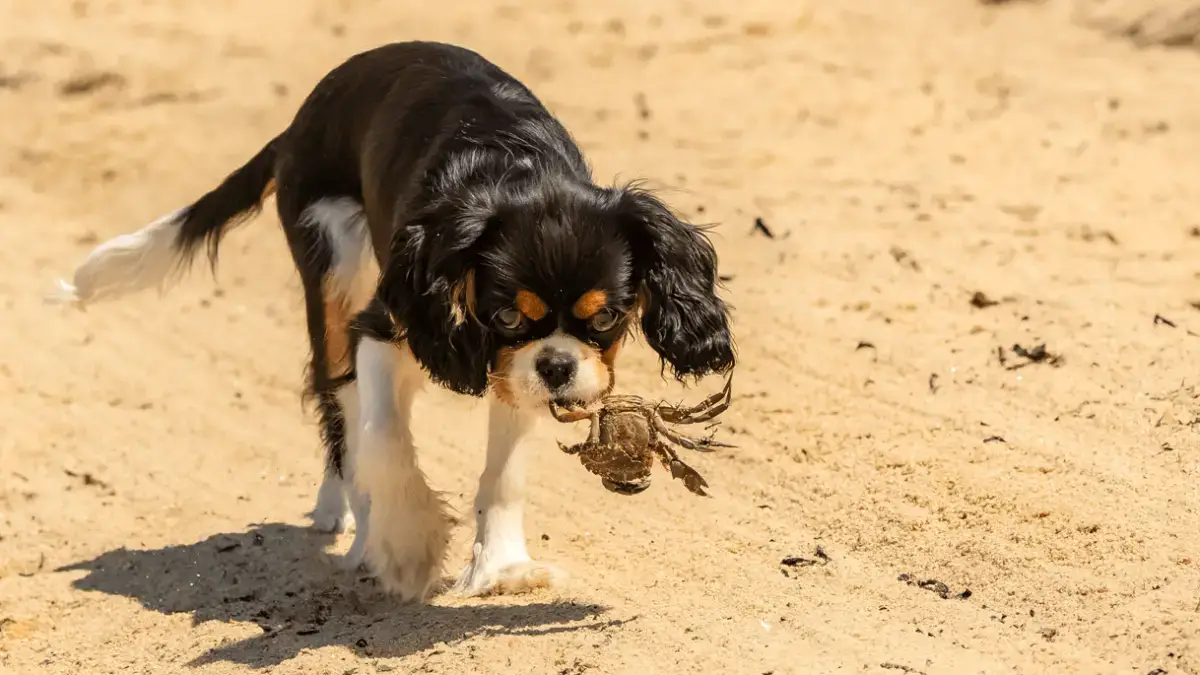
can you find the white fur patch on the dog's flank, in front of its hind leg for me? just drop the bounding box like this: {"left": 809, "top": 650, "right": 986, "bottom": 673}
{"left": 300, "top": 197, "right": 379, "bottom": 313}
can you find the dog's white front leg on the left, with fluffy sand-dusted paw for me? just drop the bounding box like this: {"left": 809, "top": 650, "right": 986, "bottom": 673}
{"left": 350, "top": 339, "right": 452, "bottom": 601}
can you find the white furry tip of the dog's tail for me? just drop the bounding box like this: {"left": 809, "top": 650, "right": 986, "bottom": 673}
{"left": 49, "top": 210, "right": 184, "bottom": 305}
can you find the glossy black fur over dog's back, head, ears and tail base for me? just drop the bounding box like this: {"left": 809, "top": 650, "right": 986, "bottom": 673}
{"left": 153, "top": 42, "right": 734, "bottom": 470}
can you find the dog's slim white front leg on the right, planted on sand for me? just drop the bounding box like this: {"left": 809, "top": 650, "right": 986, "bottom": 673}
{"left": 455, "top": 396, "right": 565, "bottom": 596}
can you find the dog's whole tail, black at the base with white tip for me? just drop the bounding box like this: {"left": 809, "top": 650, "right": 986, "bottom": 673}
{"left": 52, "top": 138, "right": 278, "bottom": 304}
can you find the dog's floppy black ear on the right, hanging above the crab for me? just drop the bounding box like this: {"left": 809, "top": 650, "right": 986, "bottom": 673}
{"left": 619, "top": 189, "right": 734, "bottom": 380}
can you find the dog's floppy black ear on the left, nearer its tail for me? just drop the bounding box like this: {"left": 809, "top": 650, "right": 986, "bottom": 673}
{"left": 378, "top": 205, "right": 491, "bottom": 396}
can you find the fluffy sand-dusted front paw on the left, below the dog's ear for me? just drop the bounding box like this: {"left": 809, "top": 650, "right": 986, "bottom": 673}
{"left": 360, "top": 483, "right": 455, "bottom": 602}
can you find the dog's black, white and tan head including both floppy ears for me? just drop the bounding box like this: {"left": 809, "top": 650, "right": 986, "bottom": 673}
{"left": 379, "top": 181, "right": 734, "bottom": 407}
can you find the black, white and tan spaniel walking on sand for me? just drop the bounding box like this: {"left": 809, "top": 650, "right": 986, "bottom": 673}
{"left": 59, "top": 42, "right": 736, "bottom": 602}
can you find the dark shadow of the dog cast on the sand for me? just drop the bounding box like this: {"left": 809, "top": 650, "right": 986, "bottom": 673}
{"left": 60, "top": 522, "right": 622, "bottom": 667}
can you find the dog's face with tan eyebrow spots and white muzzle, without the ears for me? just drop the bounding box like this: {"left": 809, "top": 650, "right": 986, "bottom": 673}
{"left": 473, "top": 208, "right": 636, "bottom": 407}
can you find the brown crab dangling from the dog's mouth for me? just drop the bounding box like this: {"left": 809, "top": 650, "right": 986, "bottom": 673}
{"left": 550, "top": 380, "right": 733, "bottom": 496}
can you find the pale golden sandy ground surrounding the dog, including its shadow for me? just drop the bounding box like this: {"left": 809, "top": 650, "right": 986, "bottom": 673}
{"left": 0, "top": 0, "right": 1200, "bottom": 675}
